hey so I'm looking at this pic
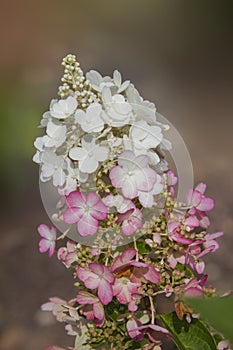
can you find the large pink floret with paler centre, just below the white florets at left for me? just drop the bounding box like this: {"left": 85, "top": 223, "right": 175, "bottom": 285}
{"left": 63, "top": 191, "right": 107, "bottom": 237}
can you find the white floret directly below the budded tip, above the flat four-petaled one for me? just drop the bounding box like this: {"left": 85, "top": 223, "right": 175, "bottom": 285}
{"left": 75, "top": 103, "right": 104, "bottom": 133}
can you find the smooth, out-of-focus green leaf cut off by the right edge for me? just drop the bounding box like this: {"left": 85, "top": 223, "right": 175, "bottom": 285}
{"left": 187, "top": 297, "right": 233, "bottom": 344}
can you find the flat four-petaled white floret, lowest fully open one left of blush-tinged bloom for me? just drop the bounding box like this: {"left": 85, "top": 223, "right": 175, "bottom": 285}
{"left": 69, "top": 135, "right": 109, "bottom": 174}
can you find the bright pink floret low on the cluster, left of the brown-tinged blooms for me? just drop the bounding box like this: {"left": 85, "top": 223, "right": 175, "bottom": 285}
{"left": 77, "top": 263, "right": 114, "bottom": 305}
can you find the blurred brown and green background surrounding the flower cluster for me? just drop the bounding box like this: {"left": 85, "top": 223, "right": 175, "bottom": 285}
{"left": 0, "top": 0, "right": 233, "bottom": 350}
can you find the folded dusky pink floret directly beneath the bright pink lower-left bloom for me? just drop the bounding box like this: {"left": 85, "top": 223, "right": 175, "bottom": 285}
{"left": 77, "top": 290, "right": 105, "bottom": 327}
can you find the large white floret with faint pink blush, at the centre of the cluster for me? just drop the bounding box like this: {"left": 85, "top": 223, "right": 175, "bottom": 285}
{"left": 109, "top": 151, "right": 156, "bottom": 199}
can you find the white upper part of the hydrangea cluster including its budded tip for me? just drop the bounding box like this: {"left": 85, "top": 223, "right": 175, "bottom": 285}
{"left": 33, "top": 55, "right": 171, "bottom": 195}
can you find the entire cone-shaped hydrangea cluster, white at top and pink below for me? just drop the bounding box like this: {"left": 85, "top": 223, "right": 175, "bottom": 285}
{"left": 34, "top": 55, "right": 229, "bottom": 350}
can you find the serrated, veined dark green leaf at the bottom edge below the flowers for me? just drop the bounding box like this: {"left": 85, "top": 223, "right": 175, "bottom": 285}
{"left": 160, "top": 312, "right": 217, "bottom": 350}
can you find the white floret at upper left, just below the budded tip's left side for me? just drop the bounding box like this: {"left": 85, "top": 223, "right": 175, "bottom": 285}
{"left": 50, "top": 96, "right": 78, "bottom": 119}
